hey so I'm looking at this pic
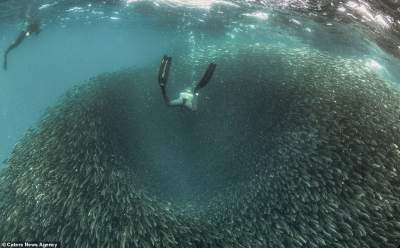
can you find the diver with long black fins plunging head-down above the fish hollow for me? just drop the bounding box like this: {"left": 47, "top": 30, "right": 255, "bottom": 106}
{"left": 158, "top": 55, "right": 217, "bottom": 111}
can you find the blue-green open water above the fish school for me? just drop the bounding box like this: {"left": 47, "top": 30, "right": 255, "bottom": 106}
{"left": 0, "top": 1, "right": 400, "bottom": 169}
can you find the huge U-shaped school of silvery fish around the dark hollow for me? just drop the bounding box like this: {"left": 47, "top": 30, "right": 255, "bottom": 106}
{"left": 0, "top": 46, "right": 400, "bottom": 248}
